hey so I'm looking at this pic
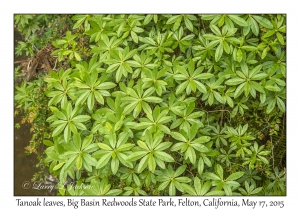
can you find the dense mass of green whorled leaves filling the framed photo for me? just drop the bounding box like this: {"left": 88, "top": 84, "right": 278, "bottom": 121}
{"left": 15, "top": 14, "right": 286, "bottom": 195}
